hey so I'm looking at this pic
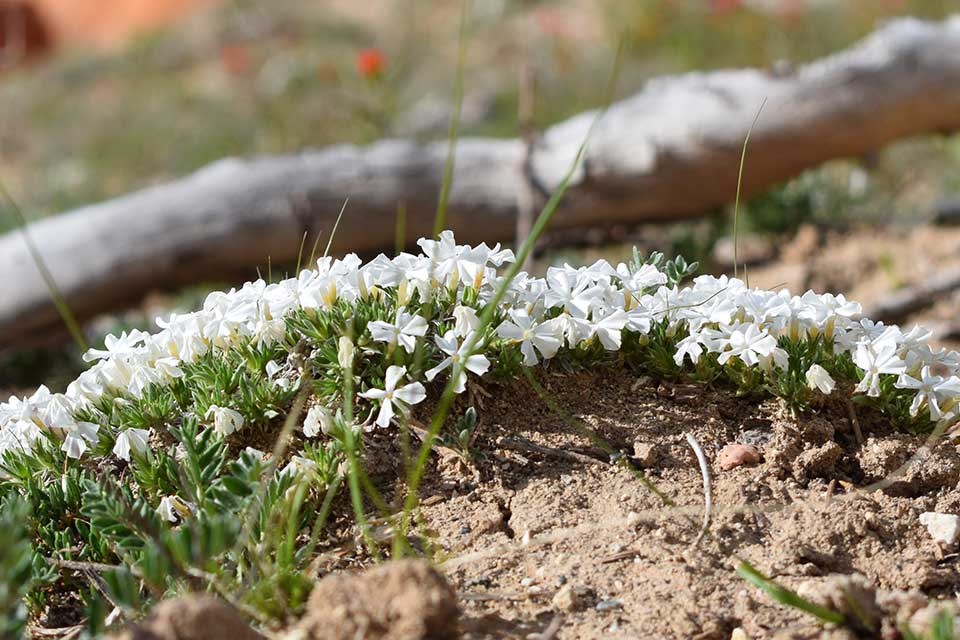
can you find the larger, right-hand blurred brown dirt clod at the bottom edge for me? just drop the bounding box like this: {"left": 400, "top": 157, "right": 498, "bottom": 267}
{"left": 295, "top": 560, "right": 459, "bottom": 640}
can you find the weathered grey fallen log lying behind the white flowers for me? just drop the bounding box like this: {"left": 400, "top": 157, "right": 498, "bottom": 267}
{"left": 0, "top": 17, "right": 960, "bottom": 345}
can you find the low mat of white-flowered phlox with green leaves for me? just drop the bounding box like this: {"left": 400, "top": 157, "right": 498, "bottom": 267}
{"left": 0, "top": 231, "right": 960, "bottom": 619}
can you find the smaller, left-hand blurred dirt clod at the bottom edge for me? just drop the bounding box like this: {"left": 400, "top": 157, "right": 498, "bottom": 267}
{"left": 114, "top": 594, "right": 265, "bottom": 640}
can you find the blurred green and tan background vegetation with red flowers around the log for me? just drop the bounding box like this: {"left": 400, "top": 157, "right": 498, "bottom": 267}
{"left": 0, "top": 0, "right": 960, "bottom": 388}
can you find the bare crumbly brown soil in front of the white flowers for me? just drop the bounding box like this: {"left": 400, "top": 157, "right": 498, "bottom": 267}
{"left": 404, "top": 369, "right": 960, "bottom": 639}
